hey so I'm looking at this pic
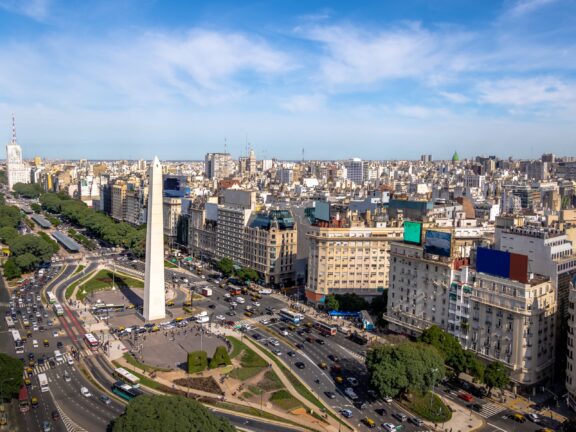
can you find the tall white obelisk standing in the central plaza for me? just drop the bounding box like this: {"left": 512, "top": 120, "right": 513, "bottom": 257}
{"left": 144, "top": 157, "right": 166, "bottom": 321}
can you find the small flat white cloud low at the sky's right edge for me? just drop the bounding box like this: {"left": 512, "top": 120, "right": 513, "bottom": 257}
{"left": 476, "top": 77, "right": 576, "bottom": 108}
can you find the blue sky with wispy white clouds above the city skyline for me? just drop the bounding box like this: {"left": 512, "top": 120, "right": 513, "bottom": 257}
{"left": 0, "top": 0, "right": 576, "bottom": 159}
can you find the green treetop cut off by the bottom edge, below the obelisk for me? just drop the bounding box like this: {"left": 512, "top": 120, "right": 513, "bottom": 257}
{"left": 112, "top": 395, "right": 236, "bottom": 432}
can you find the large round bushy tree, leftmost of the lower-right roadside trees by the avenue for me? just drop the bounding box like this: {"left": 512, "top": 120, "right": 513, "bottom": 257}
{"left": 366, "top": 342, "right": 445, "bottom": 397}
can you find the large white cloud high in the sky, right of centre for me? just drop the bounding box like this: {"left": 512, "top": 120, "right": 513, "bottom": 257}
{"left": 297, "top": 23, "right": 470, "bottom": 86}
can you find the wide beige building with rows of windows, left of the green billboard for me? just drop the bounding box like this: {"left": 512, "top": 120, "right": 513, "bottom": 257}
{"left": 306, "top": 212, "right": 403, "bottom": 303}
